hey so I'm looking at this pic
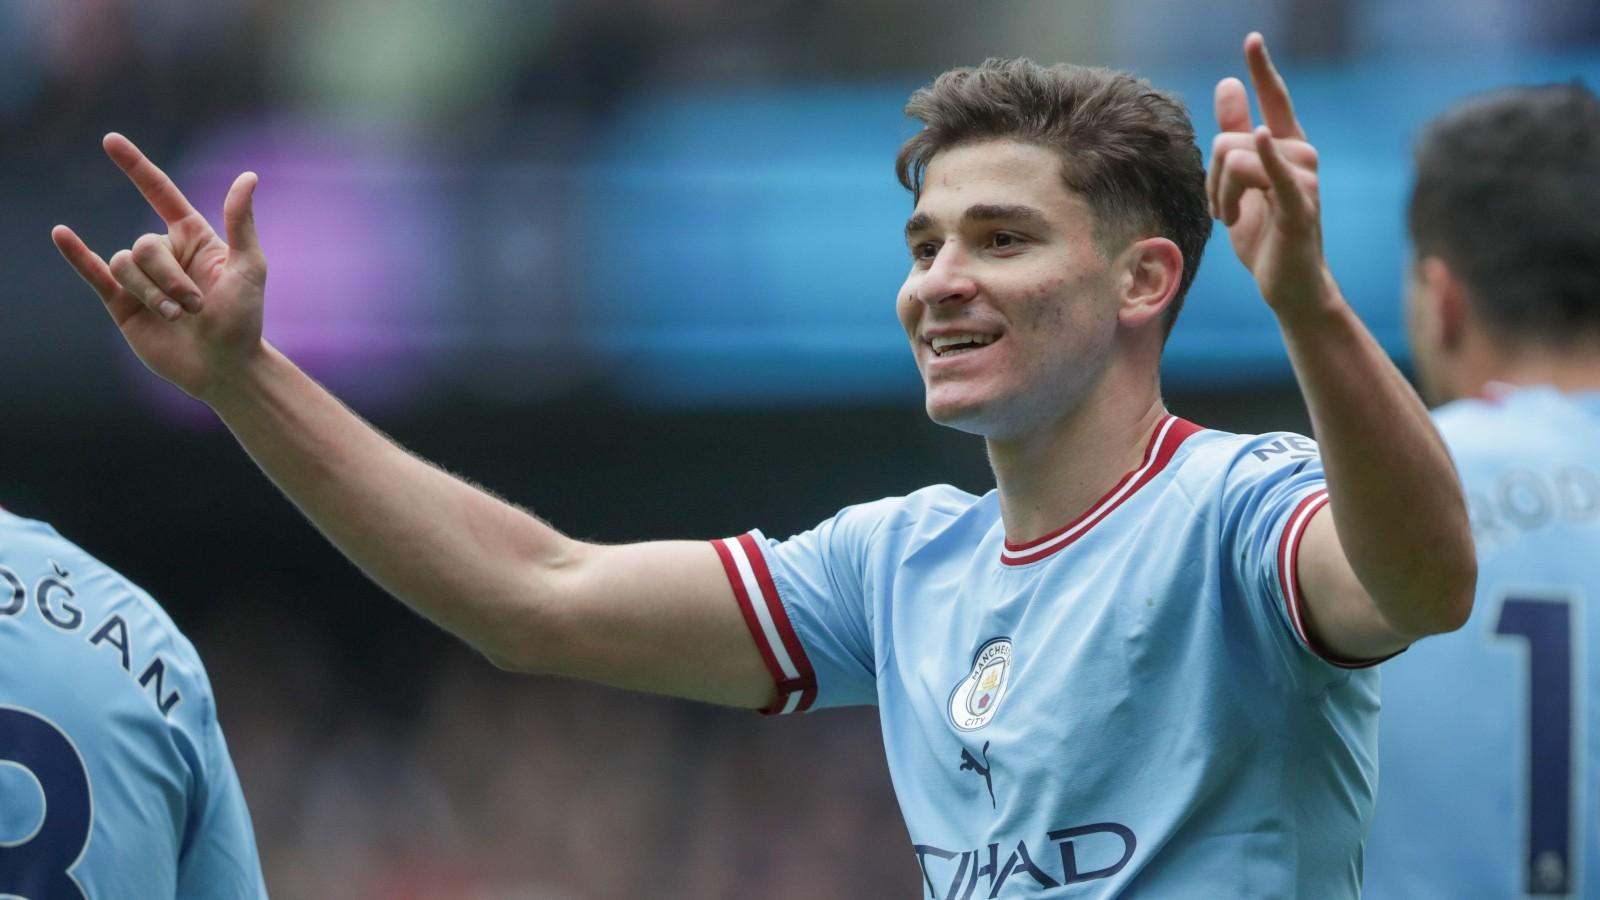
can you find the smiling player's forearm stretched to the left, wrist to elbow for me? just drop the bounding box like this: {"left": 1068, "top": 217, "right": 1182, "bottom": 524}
{"left": 206, "top": 344, "right": 581, "bottom": 660}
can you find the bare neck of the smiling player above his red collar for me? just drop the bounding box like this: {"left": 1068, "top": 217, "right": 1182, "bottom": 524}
{"left": 989, "top": 389, "right": 1166, "bottom": 543}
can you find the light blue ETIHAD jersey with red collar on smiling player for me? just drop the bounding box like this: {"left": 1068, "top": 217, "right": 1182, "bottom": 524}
{"left": 717, "top": 416, "right": 1378, "bottom": 900}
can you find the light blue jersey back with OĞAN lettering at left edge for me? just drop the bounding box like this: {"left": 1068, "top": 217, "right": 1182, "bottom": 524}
{"left": 0, "top": 511, "right": 266, "bottom": 900}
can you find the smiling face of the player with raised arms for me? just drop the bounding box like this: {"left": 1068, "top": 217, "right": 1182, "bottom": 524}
{"left": 896, "top": 139, "right": 1118, "bottom": 439}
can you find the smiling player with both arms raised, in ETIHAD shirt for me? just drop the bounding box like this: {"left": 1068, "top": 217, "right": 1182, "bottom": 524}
{"left": 54, "top": 35, "right": 1474, "bottom": 898}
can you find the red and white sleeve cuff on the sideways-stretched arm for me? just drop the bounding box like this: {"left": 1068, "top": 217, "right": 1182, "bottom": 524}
{"left": 712, "top": 533, "right": 816, "bottom": 716}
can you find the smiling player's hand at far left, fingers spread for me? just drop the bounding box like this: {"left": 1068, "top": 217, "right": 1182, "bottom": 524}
{"left": 50, "top": 133, "right": 267, "bottom": 402}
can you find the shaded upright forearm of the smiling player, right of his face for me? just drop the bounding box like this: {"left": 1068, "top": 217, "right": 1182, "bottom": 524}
{"left": 1278, "top": 269, "right": 1475, "bottom": 637}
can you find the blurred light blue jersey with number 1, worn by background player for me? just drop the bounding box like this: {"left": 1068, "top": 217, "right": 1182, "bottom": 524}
{"left": 1366, "top": 388, "right": 1600, "bottom": 900}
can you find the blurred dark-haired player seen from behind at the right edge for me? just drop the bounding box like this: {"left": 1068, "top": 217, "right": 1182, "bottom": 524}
{"left": 1368, "top": 85, "right": 1600, "bottom": 900}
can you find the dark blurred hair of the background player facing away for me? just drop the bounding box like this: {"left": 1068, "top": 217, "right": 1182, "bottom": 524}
{"left": 1410, "top": 83, "right": 1600, "bottom": 346}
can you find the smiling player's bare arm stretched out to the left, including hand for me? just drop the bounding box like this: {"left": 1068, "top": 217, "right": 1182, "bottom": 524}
{"left": 51, "top": 135, "right": 776, "bottom": 708}
